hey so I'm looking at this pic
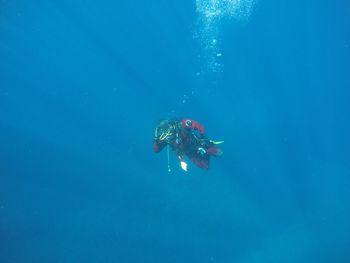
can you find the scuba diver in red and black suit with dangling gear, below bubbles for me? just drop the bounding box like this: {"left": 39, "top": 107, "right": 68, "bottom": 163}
{"left": 153, "top": 119, "right": 223, "bottom": 171}
